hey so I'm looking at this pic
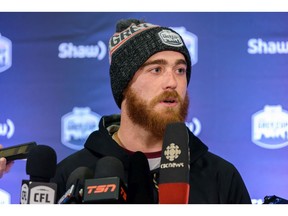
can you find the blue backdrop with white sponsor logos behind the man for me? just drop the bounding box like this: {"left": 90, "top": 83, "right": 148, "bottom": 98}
{"left": 0, "top": 12, "right": 288, "bottom": 203}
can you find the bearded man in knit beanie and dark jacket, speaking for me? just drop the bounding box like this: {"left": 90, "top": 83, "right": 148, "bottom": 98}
{"left": 54, "top": 19, "right": 251, "bottom": 204}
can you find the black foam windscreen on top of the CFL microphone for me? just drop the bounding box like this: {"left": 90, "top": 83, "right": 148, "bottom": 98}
{"left": 26, "top": 145, "right": 57, "bottom": 182}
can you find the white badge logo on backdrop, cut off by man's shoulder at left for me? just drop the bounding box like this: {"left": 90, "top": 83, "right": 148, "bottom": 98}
{"left": 61, "top": 107, "right": 101, "bottom": 150}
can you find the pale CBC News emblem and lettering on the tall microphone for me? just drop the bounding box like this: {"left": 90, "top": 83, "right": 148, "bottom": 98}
{"left": 161, "top": 143, "right": 184, "bottom": 169}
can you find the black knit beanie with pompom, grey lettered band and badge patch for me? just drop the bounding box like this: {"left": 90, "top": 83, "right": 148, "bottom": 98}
{"left": 109, "top": 19, "right": 191, "bottom": 108}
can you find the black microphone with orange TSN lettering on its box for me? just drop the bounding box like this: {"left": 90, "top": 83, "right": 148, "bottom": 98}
{"left": 83, "top": 156, "right": 127, "bottom": 204}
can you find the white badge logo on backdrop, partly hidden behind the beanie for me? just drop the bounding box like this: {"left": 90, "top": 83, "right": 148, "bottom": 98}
{"left": 171, "top": 26, "right": 198, "bottom": 65}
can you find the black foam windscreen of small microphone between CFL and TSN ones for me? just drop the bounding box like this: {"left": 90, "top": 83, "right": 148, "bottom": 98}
{"left": 66, "top": 167, "right": 94, "bottom": 190}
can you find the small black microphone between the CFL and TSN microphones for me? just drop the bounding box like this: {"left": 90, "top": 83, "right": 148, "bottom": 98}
{"left": 58, "top": 167, "right": 94, "bottom": 204}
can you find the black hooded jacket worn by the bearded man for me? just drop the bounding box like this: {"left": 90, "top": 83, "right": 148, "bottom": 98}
{"left": 52, "top": 115, "right": 251, "bottom": 204}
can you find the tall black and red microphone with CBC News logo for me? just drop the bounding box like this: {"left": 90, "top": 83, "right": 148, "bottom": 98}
{"left": 158, "top": 122, "right": 190, "bottom": 204}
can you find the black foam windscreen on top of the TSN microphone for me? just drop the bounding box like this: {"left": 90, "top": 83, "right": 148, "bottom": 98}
{"left": 94, "top": 156, "right": 124, "bottom": 180}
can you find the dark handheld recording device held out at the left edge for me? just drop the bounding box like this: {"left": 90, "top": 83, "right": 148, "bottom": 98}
{"left": 0, "top": 142, "right": 37, "bottom": 163}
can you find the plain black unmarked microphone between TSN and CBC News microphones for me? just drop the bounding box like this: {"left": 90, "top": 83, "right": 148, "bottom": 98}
{"left": 128, "top": 151, "right": 154, "bottom": 204}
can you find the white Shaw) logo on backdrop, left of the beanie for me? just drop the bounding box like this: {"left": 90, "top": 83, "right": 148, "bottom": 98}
{"left": 58, "top": 41, "right": 107, "bottom": 60}
